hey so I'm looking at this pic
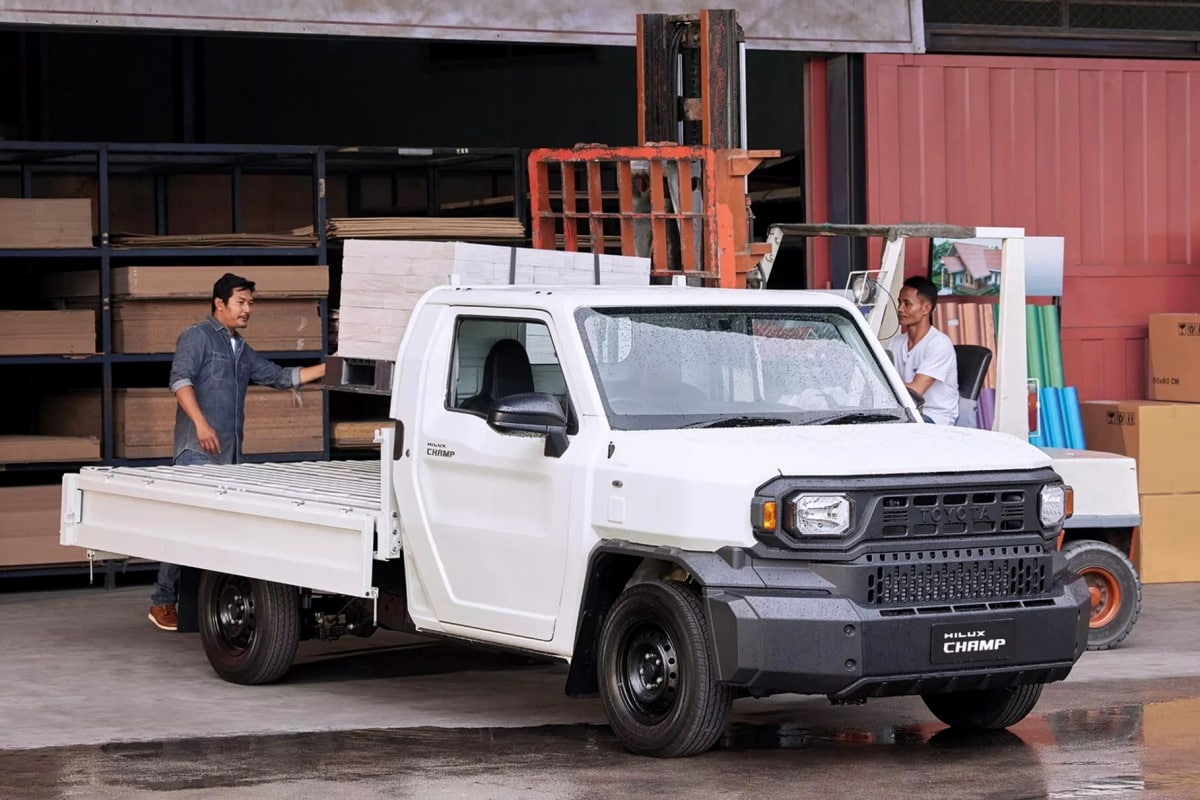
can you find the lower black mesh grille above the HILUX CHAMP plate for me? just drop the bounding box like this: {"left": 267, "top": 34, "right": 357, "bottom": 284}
{"left": 865, "top": 546, "right": 1050, "bottom": 606}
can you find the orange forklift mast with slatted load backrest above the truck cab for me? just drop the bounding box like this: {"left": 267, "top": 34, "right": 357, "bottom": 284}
{"left": 529, "top": 10, "right": 779, "bottom": 288}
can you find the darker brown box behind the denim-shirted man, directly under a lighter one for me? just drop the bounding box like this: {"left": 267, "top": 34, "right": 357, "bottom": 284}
{"left": 113, "top": 300, "right": 323, "bottom": 353}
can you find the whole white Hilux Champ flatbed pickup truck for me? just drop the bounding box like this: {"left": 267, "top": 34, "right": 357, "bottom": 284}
{"left": 61, "top": 285, "right": 1090, "bottom": 757}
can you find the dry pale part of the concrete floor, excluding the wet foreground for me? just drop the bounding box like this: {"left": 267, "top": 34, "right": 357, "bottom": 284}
{"left": 0, "top": 575, "right": 1200, "bottom": 750}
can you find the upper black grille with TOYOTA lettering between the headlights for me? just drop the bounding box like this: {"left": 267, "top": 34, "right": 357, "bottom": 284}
{"left": 877, "top": 489, "right": 1030, "bottom": 539}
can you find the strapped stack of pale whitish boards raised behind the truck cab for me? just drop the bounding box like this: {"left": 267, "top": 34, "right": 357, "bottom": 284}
{"left": 337, "top": 240, "right": 650, "bottom": 361}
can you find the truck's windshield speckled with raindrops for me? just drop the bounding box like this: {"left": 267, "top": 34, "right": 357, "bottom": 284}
{"left": 577, "top": 307, "right": 910, "bottom": 429}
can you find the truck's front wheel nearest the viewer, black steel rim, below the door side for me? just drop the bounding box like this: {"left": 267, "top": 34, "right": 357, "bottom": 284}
{"left": 598, "top": 582, "right": 733, "bottom": 758}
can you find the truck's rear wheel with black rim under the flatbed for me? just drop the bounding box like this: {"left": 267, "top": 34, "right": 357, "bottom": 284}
{"left": 197, "top": 572, "right": 300, "bottom": 685}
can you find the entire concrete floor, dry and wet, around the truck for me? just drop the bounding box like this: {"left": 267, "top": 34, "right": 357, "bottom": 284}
{"left": 0, "top": 584, "right": 1200, "bottom": 800}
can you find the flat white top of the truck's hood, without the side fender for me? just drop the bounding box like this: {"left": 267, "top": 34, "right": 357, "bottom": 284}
{"left": 613, "top": 423, "right": 1050, "bottom": 482}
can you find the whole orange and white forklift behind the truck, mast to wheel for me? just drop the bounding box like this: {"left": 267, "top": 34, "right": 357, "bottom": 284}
{"left": 528, "top": 10, "right": 1141, "bottom": 650}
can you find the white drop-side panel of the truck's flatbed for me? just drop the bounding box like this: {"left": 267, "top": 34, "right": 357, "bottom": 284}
{"left": 60, "top": 468, "right": 378, "bottom": 597}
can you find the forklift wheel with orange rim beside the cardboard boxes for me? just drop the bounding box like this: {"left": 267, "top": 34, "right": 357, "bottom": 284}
{"left": 1062, "top": 539, "right": 1141, "bottom": 650}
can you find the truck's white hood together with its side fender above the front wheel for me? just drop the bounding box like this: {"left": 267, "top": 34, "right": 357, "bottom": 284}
{"left": 592, "top": 423, "right": 1051, "bottom": 552}
